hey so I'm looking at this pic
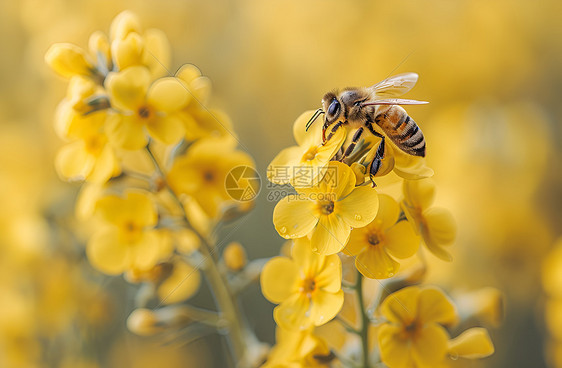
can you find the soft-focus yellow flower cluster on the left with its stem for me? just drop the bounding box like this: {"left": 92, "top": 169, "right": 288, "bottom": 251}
{"left": 45, "top": 11, "right": 260, "bottom": 365}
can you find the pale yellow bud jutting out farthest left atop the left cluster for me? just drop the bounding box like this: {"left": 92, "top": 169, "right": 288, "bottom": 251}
{"left": 45, "top": 43, "right": 95, "bottom": 78}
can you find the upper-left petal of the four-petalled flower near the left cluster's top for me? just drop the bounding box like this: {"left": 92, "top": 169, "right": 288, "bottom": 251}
{"left": 105, "top": 66, "right": 150, "bottom": 113}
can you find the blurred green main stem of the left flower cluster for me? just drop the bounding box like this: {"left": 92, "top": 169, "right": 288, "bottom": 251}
{"left": 146, "top": 145, "right": 247, "bottom": 365}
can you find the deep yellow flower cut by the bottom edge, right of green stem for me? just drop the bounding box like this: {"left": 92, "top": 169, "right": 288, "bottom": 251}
{"left": 378, "top": 286, "right": 457, "bottom": 368}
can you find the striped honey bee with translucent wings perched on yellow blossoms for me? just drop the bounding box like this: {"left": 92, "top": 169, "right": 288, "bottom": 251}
{"left": 306, "top": 73, "right": 427, "bottom": 180}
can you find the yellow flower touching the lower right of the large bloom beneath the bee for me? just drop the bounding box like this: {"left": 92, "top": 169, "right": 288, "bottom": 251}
{"left": 344, "top": 194, "right": 420, "bottom": 279}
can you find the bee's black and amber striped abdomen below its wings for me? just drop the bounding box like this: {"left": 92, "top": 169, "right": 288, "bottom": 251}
{"left": 375, "top": 105, "right": 425, "bottom": 157}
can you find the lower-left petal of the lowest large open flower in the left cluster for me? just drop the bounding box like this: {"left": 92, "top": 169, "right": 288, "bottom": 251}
{"left": 86, "top": 228, "right": 130, "bottom": 275}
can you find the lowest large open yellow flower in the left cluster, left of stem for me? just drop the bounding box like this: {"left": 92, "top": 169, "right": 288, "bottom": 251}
{"left": 86, "top": 190, "right": 171, "bottom": 274}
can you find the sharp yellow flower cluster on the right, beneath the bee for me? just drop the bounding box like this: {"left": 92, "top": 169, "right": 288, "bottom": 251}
{"left": 261, "top": 111, "right": 494, "bottom": 368}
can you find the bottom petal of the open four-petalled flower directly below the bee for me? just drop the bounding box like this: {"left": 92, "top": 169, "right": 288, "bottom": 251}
{"left": 310, "top": 214, "right": 351, "bottom": 255}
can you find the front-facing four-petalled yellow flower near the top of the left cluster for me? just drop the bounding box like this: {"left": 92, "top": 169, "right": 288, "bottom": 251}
{"left": 105, "top": 66, "right": 190, "bottom": 150}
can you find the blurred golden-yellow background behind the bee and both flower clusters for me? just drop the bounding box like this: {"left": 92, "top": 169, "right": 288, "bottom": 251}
{"left": 0, "top": 0, "right": 562, "bottom": 367}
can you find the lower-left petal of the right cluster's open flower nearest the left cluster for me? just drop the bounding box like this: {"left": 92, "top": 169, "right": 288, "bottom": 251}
{"left": 273, "top": 293, "right": 312, "bottom": 330}
